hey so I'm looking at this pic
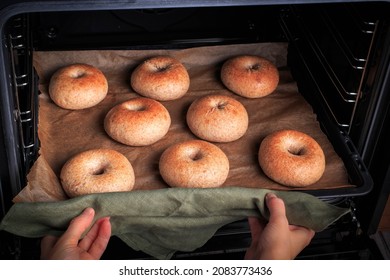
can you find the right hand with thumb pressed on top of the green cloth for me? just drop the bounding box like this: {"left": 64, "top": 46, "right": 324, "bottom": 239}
{"left": 245, "top": 193, "right": 315, "bottom": 260}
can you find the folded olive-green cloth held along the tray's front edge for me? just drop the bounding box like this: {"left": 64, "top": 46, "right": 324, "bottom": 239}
{"left": 0, "top": 187, "right": 350, "bottom": 259}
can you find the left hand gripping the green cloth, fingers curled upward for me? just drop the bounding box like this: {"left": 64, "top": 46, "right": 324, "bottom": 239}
{"left": 41, "top": 208, "right": 111, "bottom": 260}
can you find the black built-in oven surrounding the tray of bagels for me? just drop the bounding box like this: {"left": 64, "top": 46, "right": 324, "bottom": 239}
{"left": 0, "top": 0, "right": 390, "bottom": 259}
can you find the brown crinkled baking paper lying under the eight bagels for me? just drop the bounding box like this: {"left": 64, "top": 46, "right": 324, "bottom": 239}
{"left": 15, "top": 43, "right": 351, "bottom": 202}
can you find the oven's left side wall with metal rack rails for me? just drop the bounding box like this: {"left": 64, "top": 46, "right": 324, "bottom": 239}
{"left": 0, "top": 14, "right": 39, "bottom": 217}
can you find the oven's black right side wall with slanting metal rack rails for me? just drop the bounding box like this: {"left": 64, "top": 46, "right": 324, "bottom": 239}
{"left": 282, "top": 3, "right": 390, "bottom": 235}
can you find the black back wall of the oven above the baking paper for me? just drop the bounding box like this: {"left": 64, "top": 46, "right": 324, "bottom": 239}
{"left": 33, "top": 6, "right": 285, "bottom": 50}
